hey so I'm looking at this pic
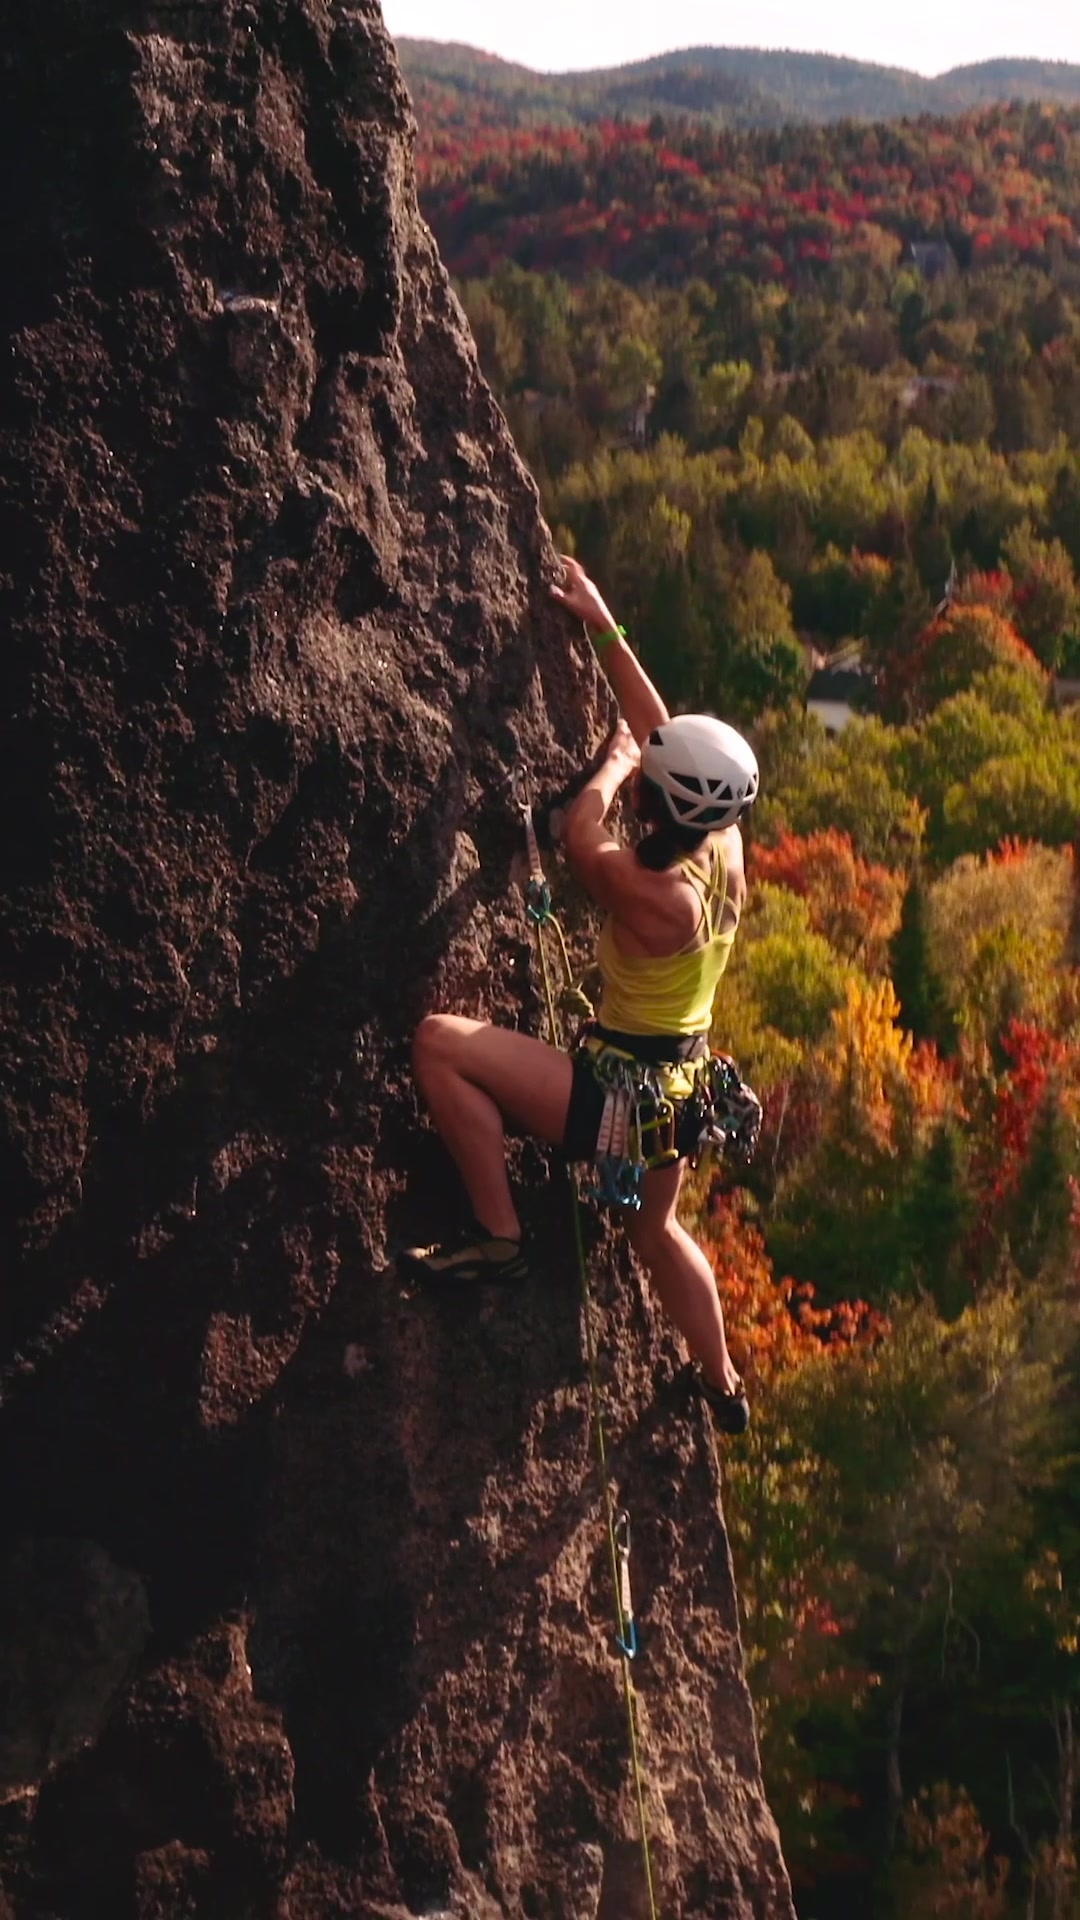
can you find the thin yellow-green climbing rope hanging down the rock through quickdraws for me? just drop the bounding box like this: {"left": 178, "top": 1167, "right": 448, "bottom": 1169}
{"left": 511, "top": 766, "right": 659, "bottom": 1920}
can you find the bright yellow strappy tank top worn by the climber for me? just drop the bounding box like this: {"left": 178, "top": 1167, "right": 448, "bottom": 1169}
{"left": 596, "top": 841, "right": 734, "bottom": 1033}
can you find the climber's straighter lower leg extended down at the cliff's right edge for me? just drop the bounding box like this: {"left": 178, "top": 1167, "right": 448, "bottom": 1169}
{"left": 626, "top": 1162, "right": 749, "bottom": 1432}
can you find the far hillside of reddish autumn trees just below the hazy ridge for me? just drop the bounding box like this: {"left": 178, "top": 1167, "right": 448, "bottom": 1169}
{"left": 421, "top": 108, "right": 1080, "bottom": 284}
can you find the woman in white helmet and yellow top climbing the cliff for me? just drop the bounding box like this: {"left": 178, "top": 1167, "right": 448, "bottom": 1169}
{"left": 400, "top": 559, "right": 757, "bottom": 1432}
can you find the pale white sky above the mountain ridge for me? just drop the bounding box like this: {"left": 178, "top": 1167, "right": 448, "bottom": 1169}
{"left": 382, "top": 0, "right": 1080, "bottom": 73}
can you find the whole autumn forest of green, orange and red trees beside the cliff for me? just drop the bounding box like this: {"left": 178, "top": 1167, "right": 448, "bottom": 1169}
{"left": 411, "top": 86, "right": 1080, "bottom": 1920}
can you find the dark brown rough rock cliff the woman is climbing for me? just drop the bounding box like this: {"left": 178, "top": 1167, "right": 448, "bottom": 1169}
{"left": 0, "top": 0, "right": 792, "bottom": 1920}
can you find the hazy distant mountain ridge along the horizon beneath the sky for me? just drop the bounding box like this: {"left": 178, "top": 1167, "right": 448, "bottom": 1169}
{"left": 398, "top": 38, "right": 1080, "bottom": 131}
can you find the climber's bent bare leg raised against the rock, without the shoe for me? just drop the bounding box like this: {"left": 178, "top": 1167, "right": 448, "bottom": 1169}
{"left": 413, "top": 1014, "right": 573, "bottom": 1240}
